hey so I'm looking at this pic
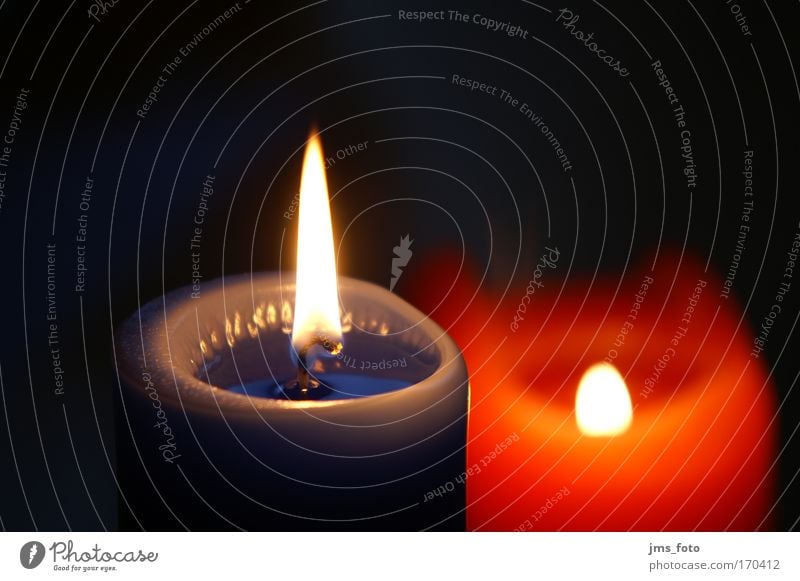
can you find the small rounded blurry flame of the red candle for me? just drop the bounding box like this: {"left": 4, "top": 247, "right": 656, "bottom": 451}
{"left": 575, "top": 363, "right": 633, "bottom": 436}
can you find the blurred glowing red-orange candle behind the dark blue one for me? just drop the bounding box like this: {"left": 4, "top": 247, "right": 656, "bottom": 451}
{"left": 410, "top": 249, "right": 776, "bottom": 531}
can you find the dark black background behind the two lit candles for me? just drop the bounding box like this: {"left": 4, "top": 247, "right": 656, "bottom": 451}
{"left": 0, "top": 0, "right": 800, "bottom": 530}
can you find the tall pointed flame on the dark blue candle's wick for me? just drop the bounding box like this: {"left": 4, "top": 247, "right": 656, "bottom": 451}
{"left": 292, "top": 135, "right": 342, "bottom": 351}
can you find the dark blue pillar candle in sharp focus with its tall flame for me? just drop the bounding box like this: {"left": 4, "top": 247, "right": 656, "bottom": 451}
{"left": 116, "top": 137, "right": 468, "bottom": 530}
